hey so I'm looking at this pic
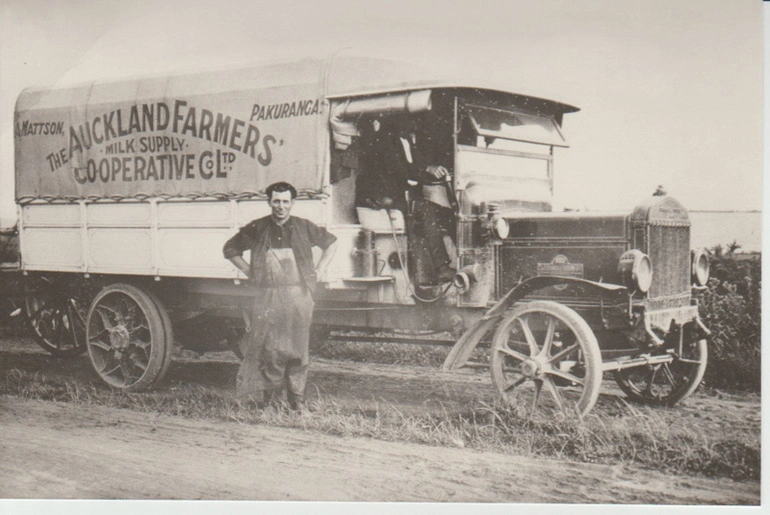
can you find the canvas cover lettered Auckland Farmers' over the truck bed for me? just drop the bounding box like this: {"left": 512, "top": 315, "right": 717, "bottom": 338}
{"left": 15, "top": 57, "right": 326, "bottom": 201}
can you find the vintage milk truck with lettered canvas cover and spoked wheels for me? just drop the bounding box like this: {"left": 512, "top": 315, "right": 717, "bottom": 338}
{"left": 14, "top": 56, "right": 709, "bottom": 415}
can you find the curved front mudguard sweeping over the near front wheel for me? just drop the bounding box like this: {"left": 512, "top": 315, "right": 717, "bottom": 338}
{"left": 441, "top": 276, "right": 627, "bottom": 370}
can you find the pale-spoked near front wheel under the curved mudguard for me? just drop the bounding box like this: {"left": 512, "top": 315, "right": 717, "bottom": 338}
{"left": 492, "top": 301, "right": 602, "bottom": 416}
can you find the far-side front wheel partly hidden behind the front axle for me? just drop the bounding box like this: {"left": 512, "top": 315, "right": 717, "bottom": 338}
{"left": 614, "top": 340, "right": 708, "bottom": 406}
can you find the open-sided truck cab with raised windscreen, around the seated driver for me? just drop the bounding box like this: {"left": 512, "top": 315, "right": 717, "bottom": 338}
{"left": 320, "top": 87, "right": 577, "bottom": 307}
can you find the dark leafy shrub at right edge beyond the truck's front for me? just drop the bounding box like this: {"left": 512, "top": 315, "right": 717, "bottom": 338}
{"left": 700, "top": 253, "right": 762, "bottom": 391}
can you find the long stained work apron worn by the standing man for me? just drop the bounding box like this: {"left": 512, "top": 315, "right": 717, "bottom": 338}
{"left": 236, "top": 248, "right": 313, "bottom": 402}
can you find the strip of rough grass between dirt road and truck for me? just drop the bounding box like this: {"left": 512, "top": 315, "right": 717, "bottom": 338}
{"left": 0, "top": 368, "right": 760, "bottom": 480}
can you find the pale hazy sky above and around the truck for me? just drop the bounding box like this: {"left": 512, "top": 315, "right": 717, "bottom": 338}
{"left": 0, "top": 0, "right": 762, "bottom": 227}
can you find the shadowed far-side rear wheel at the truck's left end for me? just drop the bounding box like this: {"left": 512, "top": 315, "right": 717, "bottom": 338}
{"left": 24, "top": 276, "right": 88, "bottom": 358}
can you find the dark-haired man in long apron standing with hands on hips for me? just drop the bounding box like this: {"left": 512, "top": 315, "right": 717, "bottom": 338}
{"left": 223, "top": 182, "right": 337, "bottom": 409}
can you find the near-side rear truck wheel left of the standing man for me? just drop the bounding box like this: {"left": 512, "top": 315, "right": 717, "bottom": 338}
{"left": 86, "top": 284, "right": 173, "bottom": 391}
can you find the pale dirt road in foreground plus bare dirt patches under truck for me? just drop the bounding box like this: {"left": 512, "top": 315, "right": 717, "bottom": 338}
{"left": 0, "top": 334, "right": 759, "bottom": 504}
